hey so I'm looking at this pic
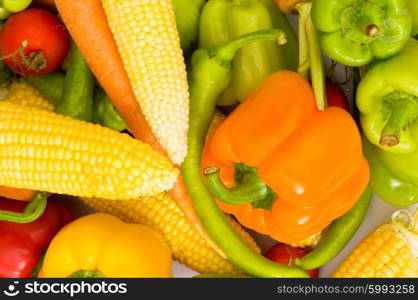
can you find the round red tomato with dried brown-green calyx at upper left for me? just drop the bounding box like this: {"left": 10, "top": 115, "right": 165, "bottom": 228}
{"left": 0, "top": 8, "right": 70, "bottom": 76}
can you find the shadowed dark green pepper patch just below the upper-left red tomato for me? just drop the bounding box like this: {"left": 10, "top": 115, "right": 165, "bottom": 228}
{"left": 25, "top": 71, "right": 65, "bottom": 106}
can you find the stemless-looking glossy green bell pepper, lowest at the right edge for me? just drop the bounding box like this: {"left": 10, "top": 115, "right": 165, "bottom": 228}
{"left": 363, "top": 137, "right": 418, "bottom": 207}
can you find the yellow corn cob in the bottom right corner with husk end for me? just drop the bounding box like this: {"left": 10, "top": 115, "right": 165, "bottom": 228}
{"left": 333, "top": 210, "right": 418, "bottom": 278}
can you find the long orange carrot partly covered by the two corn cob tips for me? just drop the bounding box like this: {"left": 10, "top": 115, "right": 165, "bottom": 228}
{"left": 55, "top": 0, "right": 223, "bottom": 255}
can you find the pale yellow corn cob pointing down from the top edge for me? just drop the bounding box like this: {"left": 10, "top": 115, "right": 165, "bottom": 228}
{"left": 102, "top": 0, "right": 189, "bottom": 164}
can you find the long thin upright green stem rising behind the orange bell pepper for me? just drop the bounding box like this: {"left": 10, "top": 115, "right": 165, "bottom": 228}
{"left": 295, "top": 2, "right": 327, "bottom": 111}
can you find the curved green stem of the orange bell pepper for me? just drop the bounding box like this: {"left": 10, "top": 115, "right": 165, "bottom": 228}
{"left": 204, "top": 167, "right": 270, "bottom": 205}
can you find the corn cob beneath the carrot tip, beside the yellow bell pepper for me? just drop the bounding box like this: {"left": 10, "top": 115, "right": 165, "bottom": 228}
{"left": 82, "top": 193, "right": 260, "bottom": 274}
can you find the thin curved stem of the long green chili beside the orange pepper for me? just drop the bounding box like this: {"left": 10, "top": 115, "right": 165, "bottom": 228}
{"left": 210, "top": 29, "right": 287, "bottom": 61}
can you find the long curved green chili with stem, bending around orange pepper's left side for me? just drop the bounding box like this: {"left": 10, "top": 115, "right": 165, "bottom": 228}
{"left": 182, "top": 30, "right": 308, "bottom": 277}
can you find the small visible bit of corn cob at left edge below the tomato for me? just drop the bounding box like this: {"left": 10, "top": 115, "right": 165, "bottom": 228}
{"left": 4, "top": 78, "right": 54, "bottom": 111}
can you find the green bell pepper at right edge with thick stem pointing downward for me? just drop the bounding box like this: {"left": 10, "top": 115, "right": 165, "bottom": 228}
{"left": 356, "top": 38, "right": 418, "bottom": 153}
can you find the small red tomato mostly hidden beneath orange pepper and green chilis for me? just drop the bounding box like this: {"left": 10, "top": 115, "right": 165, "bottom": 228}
{"left": 264, "top": 243, "right": 319, "bottom": 278}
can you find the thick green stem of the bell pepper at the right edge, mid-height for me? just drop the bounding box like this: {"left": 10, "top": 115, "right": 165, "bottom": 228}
{"left": 379, "top": 92, "right": 418, "bottom": 147}
